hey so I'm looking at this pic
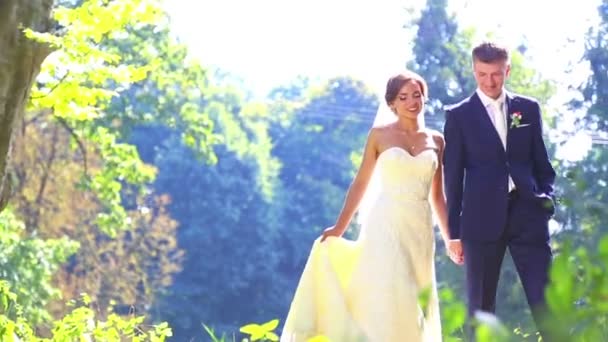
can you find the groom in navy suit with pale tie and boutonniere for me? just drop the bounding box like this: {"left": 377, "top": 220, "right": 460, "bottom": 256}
{"left": 443, "top": 43, "right": 555, "bottom": 339}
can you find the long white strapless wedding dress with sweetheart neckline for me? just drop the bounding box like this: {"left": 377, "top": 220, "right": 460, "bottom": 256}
{"left": 281, "top": 147, "right": 441, "bottom": 342}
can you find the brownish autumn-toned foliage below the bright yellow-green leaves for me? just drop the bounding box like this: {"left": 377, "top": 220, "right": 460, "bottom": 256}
{"left": 6, "top": 116, "right": 181, "bottom": 324}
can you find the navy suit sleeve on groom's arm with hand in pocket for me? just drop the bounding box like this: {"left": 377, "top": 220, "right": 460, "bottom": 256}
{"left": 532, "top": 103, "right": 555, "bottom": 197}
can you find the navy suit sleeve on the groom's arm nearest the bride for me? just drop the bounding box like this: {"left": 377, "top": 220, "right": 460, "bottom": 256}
{"left": 443, "top": 110, "right": 465, "bottom": 239}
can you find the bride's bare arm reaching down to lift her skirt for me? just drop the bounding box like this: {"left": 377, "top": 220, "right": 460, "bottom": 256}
{"left": 323, "top": 128, "right": 378, "bottom": 237}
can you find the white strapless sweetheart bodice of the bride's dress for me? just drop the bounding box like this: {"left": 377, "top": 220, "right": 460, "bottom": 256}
{"left": 376, "top": 147, "right": 438, "bottom": 201}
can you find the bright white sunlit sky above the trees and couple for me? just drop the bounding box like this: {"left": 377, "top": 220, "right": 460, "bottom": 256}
{"left": 167, "top": 0, "right": 599, "bottom": 95}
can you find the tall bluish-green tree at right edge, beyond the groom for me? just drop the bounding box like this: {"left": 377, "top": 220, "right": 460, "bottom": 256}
{"left": 558, "top": 0, "right": 608, "bottom": 246}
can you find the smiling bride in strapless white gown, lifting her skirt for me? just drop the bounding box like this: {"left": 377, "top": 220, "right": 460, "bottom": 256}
{"left": 281, "top": 71, "right": 458, "bottom": 342}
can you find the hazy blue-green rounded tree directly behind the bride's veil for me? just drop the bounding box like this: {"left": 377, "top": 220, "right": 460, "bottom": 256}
{"left": 270, "top": 77, "right": 378, "bottom": 268}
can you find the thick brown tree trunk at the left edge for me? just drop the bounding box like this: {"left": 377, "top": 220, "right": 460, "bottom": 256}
{"left": 0, "top": 0, "right": 53, "bottom": 211}
